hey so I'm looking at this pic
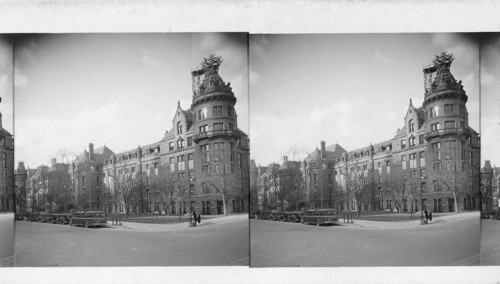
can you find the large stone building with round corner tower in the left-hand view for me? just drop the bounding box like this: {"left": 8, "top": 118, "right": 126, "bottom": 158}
{"left": 21, "top": 56, "right": 250, "bottom": 215}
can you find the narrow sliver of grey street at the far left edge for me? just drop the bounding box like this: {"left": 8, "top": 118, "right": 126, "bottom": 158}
{"left": 0, "top": 213, "right": 14, "bottom": 267}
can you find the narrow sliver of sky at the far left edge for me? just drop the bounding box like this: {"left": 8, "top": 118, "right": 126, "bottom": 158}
{"left": 0, "top": 35, "right": 14, "bottom": 134}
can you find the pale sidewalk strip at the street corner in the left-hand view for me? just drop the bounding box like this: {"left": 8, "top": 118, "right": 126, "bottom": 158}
{"left": 105, "top": 213, "right": 248, "bottom": 232}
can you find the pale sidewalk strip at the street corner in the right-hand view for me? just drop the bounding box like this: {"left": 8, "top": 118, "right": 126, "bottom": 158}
{"left": 339, "top": 211, "right": 480, "bottom": 229}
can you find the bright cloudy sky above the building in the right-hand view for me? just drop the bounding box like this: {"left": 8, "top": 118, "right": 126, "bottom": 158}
{"left": 249, "top": 34, "right": 479, "bottom": 165}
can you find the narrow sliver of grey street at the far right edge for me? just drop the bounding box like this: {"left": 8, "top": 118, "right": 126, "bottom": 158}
{"left": 481, "top": 219, "right": 500, "bottom": 265}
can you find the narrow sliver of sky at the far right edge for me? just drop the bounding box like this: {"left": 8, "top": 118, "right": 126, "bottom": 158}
{"left": 481, "top": 33, "right": 500, "bottom": 167}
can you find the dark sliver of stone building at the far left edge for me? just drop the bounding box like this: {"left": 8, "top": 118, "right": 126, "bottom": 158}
{"left": 0, "top": 110, "right": 15, "bottom": 212}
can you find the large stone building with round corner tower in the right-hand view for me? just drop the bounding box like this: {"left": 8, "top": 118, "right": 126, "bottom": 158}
{"left": 258, "top": 53, "right": 480, "bottom": 212}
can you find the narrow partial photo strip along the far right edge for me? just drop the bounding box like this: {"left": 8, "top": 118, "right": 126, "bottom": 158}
{"left": 480, "top": 33, "right": 500, "bottom": 265}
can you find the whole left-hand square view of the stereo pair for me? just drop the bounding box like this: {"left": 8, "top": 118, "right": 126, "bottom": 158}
{"left": 13, "top": 33, "right": 249, "bottom": 267}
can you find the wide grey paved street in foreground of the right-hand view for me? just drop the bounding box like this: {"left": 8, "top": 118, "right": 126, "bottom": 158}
{"left": 254, "top": 212, "right": 480, "bottom": 267}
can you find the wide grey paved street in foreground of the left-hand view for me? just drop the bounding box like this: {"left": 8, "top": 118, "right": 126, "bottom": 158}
{"left": 15, "top": 216, "right": 249, "bottom": 266}
